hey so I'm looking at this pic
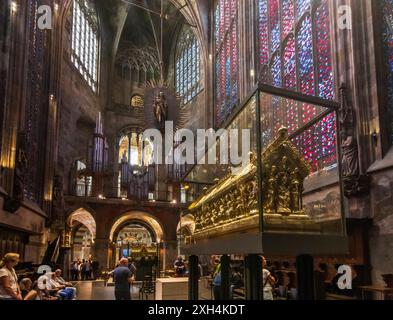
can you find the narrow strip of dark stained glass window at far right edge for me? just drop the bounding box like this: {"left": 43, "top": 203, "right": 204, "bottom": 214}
{"left": 380, "top": 0, "right": 393, "bottom": 144}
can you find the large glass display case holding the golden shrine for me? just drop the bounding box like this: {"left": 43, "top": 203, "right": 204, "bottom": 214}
{"left": 184, "top": 85, "right": 347, "bottom": 255}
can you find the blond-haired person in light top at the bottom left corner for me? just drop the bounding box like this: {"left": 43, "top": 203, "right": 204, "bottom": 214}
{"left": 0, "top": 253, "right": 23, "bottom": 300}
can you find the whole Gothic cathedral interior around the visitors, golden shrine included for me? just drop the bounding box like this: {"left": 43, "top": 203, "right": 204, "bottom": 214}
{"left": 0, "top": 0, "right": 393, "bottom": 300}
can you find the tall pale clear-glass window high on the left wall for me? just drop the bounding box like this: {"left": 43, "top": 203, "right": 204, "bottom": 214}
{"left": 71, "top": 0, "right": 99, "bottom": 92}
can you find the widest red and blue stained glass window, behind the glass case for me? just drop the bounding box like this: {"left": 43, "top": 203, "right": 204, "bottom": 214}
{"left": 257, "top": 0, "right": 334, "bottom": 171}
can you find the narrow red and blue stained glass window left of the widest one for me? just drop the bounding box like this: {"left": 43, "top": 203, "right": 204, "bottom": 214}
{"left": 214, "top": 0, "right": 239, "bottom": 127}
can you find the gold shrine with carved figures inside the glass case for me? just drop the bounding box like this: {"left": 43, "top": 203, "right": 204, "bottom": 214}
{"left": 189, "top": 128, "right": 310, "bottom": 233}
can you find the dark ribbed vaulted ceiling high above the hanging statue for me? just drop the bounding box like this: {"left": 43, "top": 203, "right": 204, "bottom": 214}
{"left": 92, "top": 0, "right": 211, "bottom": 71}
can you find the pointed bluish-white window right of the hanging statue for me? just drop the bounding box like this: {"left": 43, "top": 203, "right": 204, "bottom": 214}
{"left": 175, "top": 26, "right": 200, "bottom": 105}
